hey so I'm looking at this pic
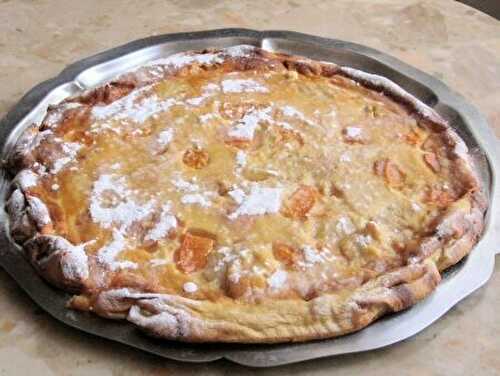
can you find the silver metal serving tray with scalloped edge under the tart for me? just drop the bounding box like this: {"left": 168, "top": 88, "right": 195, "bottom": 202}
{"left": 0, "top": 29, "right": 500, "bottom": 367}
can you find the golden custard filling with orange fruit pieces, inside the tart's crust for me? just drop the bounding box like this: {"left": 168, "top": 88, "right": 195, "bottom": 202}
{"left": 26, "top": 65, "right": 464, "bottom": 301}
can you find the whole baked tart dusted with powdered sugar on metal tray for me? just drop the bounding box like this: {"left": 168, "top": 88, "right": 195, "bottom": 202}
{"left": 6, "top": 46, "right": 486, "bottom": 343}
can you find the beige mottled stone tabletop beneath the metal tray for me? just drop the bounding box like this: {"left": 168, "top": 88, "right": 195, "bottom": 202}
{"left": 0, "top": 0, "right": 500, "bottom": 376}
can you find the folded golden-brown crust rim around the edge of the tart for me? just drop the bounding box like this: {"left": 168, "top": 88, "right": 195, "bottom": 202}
{"left": 1, "top": 47, "right": 487, "bottom": 343}
